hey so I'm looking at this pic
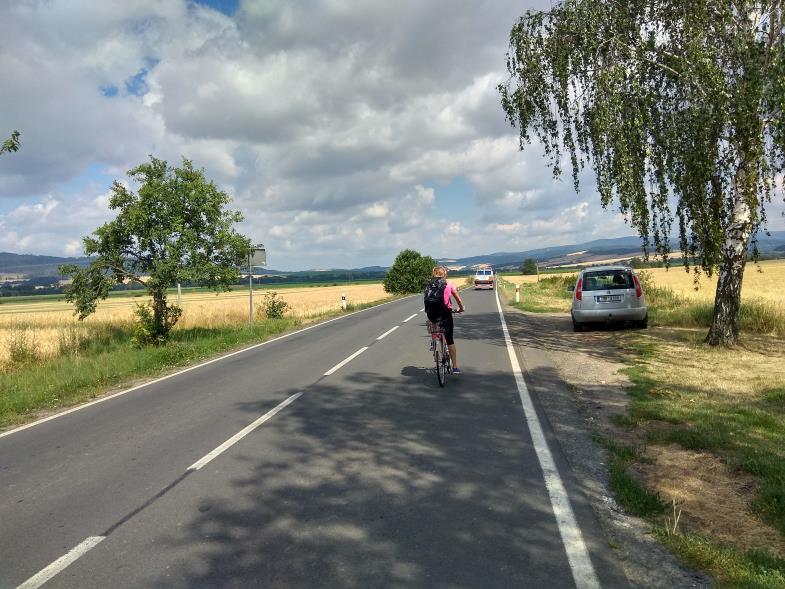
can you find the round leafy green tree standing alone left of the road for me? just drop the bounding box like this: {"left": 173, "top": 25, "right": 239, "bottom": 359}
{"left": 60, "top": 156, "right": 251, "bottom": 343}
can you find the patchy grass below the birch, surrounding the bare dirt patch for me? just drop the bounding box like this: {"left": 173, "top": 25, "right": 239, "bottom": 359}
{"left": 612, "top": 329, "right": 785, "bottom": 588}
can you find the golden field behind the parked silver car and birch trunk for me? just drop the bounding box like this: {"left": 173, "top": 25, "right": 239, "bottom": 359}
{"left": 504, "top": 260, "right": 785, "bottom": 305}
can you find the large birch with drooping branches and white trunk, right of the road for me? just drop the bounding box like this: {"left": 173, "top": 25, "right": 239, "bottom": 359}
{"left": 499, "top": 0, "right": 785, "bottom": 345}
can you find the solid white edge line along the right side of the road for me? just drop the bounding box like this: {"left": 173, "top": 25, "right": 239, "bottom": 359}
{"left": 494, "top": 293, "right": 600, "bottom": 589}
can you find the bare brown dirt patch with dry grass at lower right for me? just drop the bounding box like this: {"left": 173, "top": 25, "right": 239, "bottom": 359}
{"left": 631, "top": 444, "right": 785, "bottom": 557}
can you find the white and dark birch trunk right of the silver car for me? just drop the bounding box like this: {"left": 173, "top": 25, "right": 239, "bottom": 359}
{"left": 706, "top": 170, "right": 752, "bottom": 346}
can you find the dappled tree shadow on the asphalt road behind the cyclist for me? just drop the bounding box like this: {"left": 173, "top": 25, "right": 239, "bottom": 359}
{"left": 144, "top": 366, "right": 592, "bottom": 587}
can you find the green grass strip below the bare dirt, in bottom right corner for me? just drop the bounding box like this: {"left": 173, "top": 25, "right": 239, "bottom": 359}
{"left": 656, "top": 529, "right": 785, "bottom": 589}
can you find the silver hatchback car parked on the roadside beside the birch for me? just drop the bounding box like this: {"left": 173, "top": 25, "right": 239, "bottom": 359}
{"left": 572, "top": 265, "right": 649, "bottom": 331}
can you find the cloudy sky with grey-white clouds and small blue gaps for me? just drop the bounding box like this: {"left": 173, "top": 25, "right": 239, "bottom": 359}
{"left": 0, "top": 0, "right": 783, "bottom": 270}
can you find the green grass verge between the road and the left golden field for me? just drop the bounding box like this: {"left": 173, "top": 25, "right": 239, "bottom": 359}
{"left": 0, "top": 297, "right": 398, "bottom": 427}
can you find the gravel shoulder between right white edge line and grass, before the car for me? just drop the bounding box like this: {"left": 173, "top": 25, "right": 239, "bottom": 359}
{"left": 500, "top": 300, "right": 713, "bottom": 589}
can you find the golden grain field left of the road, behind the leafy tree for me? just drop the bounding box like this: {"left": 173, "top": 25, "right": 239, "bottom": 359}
{"left": 0, "top": 283, "right": 387, "bottom": 366}
